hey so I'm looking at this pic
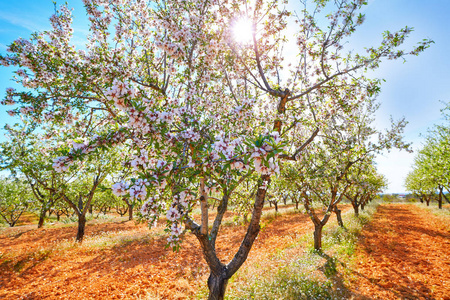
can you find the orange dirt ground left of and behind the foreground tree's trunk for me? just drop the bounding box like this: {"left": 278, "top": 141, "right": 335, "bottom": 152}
{"left": 0, "top": 205, "right": 350, "bottom": 299}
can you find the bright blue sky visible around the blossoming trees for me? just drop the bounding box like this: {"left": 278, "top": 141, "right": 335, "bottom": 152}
{"left": 0, "top": 0, "right": 450, "bottom": 192}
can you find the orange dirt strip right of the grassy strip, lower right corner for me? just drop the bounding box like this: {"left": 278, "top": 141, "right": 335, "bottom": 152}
{"left": 352, "top": 204, "right": 450, "bottom": 300}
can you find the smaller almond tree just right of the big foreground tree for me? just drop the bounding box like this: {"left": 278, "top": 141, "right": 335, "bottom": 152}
{"left": 283, "top": 100, "right": 409, "bottom": 251}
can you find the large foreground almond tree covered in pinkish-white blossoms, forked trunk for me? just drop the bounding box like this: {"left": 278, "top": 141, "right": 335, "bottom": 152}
{"left": 0, "top": 0, "right": 430, "bottom": 299}
